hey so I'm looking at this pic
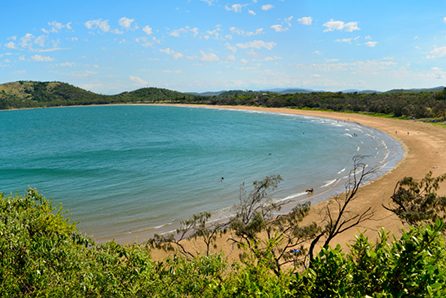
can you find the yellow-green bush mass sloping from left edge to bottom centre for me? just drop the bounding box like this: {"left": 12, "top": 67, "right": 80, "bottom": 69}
{"left": 0, "top": 189, "right": 287, "bottom": 297}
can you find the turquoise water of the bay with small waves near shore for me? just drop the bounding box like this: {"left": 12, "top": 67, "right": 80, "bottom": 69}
{"left": 0, "top": 106, "right": 401, "bottom": 240}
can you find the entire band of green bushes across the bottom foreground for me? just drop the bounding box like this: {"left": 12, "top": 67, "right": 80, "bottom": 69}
{"left": 0, "top": 189, "right": 446, "bottom": 297}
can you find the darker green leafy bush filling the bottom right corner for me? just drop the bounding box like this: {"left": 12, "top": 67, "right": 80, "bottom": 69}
{"left": 292, "top": 221, "right": 446, "bottom": 297}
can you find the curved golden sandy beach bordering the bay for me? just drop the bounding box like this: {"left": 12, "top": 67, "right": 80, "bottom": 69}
{"left": 152, "top": 105, "right": 446, "bottom": 259}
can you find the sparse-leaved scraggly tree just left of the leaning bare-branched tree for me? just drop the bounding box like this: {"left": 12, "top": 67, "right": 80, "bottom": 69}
{"left": 230, "top": 176, "right": 318, "bottom": 276}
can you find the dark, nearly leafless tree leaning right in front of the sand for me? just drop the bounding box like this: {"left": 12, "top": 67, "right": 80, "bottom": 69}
{"left": 309, "top": 155, "right": 375, "bottom": 266}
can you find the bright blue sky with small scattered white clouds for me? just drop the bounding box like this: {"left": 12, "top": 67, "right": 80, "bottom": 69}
{"left": 0, "top": 0, "right": 446, "bottom": 94}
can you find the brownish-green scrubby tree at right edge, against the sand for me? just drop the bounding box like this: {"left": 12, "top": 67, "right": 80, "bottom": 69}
{"left": 383, "top": 172, "right": 446, "bottom": 225}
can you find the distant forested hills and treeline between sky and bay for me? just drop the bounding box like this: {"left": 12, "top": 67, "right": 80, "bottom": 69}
{"left": 0, "top": 81, "right": 446, "bottom": 121}
